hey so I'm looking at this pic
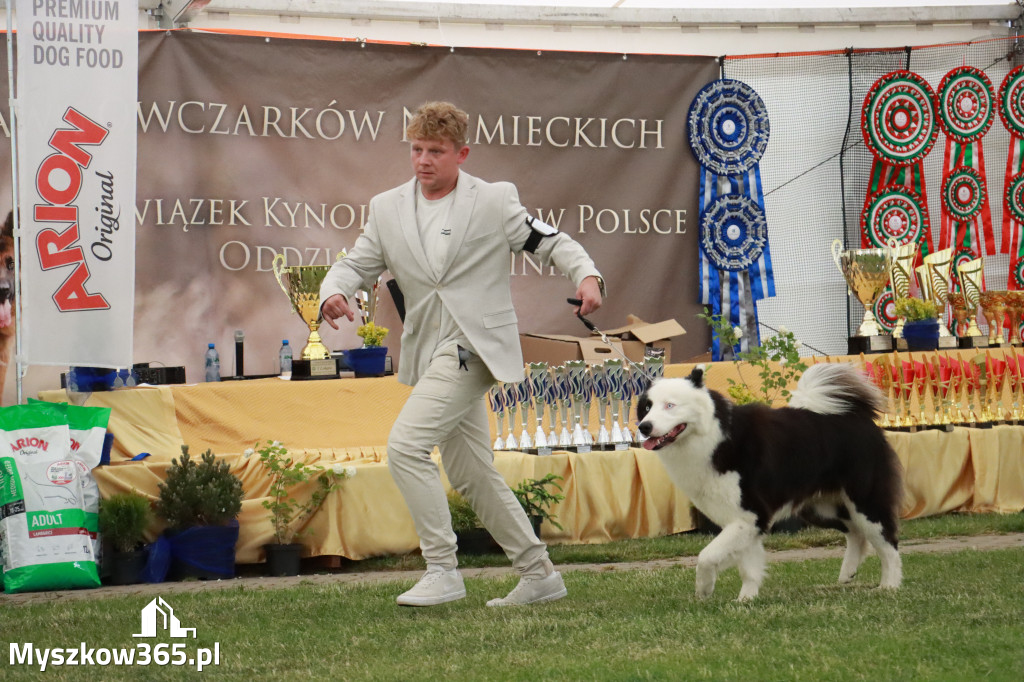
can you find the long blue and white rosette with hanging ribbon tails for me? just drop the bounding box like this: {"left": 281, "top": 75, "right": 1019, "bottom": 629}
{"left": 689, "top": 78, "right": 775, "bottom": 360}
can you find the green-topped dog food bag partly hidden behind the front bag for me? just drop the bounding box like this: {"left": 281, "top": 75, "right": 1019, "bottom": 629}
{"left": 29, "top": 398, "right": 111, "bottom": 565}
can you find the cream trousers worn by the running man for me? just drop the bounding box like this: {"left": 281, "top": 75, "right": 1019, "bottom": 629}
{"left": 387, "top": 344, "right": 552, "bottom": 578}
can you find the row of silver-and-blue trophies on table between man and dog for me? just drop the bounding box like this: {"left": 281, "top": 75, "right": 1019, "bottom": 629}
{"left": 487, "top": 357, "right": 665, "bottom": 455}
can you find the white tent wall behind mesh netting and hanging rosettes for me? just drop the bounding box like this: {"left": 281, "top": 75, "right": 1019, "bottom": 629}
{"left": 722, "top": 38, "right": 1021, "bottom": 355}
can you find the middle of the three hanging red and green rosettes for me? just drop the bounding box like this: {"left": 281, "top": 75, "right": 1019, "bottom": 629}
{"left": 936, "top": 66, "right": 995, "bottom": 256}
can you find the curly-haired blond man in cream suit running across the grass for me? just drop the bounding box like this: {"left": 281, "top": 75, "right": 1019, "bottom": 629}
{"left": 321, "top": 102, "right": 604, "bottom": 606}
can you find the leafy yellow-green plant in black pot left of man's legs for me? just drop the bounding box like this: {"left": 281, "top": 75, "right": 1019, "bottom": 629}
{"left": 246, "top": 440, "right": 355, "bottom": 576}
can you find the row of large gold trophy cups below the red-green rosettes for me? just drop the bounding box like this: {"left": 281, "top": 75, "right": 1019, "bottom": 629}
{"left": 833, "top": 240, "right": 1024, "bottom": 354}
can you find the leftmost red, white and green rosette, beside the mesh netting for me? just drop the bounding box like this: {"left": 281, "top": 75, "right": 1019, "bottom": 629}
{"left": 860, "top": 71, "right": 939, "bottom": 255}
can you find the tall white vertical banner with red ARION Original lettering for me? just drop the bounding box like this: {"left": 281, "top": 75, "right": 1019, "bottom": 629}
{"left": 15, "top": 0, "right": 138, "bottom": 367}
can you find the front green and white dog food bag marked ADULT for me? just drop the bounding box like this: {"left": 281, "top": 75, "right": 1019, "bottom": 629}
{"left": 0, "top": 402, "right": 99, "bottom": 593}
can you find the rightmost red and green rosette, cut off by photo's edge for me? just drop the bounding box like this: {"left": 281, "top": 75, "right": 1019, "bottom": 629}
{"left": 999, "top": 67, "right": 1024, "bottom": 289}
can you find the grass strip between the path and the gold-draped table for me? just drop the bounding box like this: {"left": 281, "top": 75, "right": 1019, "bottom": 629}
{"left": 345, "top": 513, "right": 1024, "bottom": 570}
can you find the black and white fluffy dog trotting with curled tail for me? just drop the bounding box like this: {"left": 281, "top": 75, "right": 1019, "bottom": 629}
{"left": 637, "top": 364, "right": 902, "bottom": 601}
